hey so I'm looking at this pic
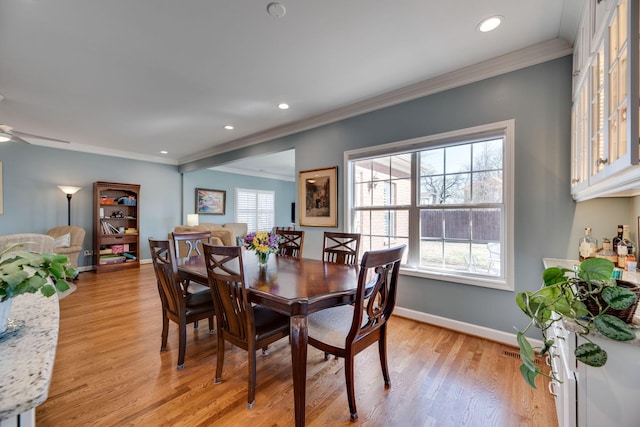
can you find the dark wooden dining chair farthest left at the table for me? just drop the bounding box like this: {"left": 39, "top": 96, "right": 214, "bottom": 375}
{"left": 149, "top": 238, "right": 215, "bottom": 371}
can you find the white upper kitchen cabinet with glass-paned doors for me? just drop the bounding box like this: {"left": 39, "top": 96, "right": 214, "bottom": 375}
{"left": 571, "top": 0, "right": 640, "bottom": 201}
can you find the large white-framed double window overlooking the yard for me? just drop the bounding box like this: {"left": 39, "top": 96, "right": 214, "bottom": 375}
{"left": 345, "top": 121, "right": 513, "bottom": 289}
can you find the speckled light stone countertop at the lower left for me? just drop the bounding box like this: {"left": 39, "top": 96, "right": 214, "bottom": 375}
{"left": 0, "top": 293, "right": 60, "bottom": 420}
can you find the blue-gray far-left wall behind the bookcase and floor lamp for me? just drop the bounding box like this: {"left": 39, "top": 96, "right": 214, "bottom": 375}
{"left": 0, "top": 143, "right": 181, "bottom": 266}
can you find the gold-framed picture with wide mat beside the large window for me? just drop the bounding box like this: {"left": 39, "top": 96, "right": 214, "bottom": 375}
{"left": 298, "top": 166, "right": 338, "bottom": 227}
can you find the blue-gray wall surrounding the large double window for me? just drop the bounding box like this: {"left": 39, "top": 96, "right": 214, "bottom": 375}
{"left": 183, "top": 57, "right": 631, "bottom": 333}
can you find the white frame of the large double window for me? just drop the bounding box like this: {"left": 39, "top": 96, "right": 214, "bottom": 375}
{"left": 343, "top": 119, "right": 515, "bottom": 291}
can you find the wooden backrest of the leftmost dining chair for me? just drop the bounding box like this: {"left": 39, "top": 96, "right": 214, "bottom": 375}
{"left": 149, "top": 238, "right": 185, "bottom": 315}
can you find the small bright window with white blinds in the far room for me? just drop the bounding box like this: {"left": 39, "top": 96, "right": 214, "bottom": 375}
{"left": 236, "top": 188, "right": 275, "bottom": 232}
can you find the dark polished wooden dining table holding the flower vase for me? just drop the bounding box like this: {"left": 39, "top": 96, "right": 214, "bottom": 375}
{"left": 178, "top": 251, "right": 359, "bottom": 427}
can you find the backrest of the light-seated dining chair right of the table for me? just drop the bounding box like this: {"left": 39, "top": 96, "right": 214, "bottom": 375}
{"left": 347, "top": 245, "right": 406, "bottom": 345}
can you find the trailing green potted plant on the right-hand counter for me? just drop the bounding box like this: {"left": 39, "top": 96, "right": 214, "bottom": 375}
{"left": 516, "top": 258, "right": 637, "bottom": 388}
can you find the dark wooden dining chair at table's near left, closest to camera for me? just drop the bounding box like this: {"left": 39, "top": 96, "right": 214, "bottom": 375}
{"left": 204, "top": 244, "right": 289, "bottom": 409}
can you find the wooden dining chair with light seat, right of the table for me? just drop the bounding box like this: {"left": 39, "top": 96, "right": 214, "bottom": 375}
{"left": 308, "top": 245, "right": 406, "bottom": 421}
